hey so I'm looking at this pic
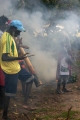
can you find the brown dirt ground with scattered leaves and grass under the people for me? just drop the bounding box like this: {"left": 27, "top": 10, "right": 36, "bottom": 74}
{"left": 0, "top": 80, "right": 80, "bottom": 120}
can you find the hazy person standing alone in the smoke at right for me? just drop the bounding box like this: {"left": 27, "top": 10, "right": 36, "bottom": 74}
{"left": 56, "top": 43, "right": 72, "bottom": 94}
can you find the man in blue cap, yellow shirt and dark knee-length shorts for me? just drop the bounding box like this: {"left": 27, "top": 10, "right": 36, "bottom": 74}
{"left": 0, "top": 20, "right": 27, "bottom": 120}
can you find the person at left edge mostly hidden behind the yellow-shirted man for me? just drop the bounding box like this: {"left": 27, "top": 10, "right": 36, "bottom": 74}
{"left": 0, "top": 15, "right": 9, "bottom": 109}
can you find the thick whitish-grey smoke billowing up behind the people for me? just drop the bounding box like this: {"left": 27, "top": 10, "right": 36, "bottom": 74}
{"left": 0, "top": 0, "right": 79, "bottom": 81}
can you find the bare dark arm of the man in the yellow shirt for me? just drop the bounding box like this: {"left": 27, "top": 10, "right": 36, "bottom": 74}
{"left": 2, "top": 53, "right": 27, "bottom": 62}
